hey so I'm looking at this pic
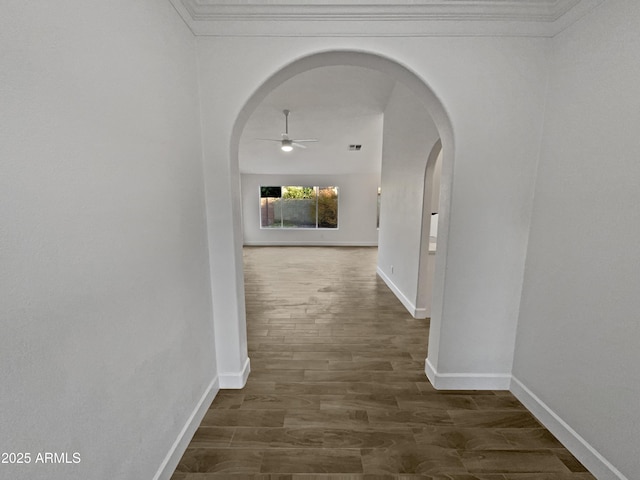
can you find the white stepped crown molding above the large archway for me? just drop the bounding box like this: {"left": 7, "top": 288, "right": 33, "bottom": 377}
{"left": 170, "top": 0, "right": 604, "bottom": 36}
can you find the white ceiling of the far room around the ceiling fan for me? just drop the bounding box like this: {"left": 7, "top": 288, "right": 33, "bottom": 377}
{"left": 239, "top": 66, "right": 395, "bottom": 174}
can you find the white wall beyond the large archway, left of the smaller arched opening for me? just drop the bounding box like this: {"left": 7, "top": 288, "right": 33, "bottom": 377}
{"left": 378, "top": 83, "right": 440, "bottom": 317}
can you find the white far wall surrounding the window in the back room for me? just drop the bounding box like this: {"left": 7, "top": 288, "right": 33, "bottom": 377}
{"left": 242, "top": 173, "right": 380, "bottom": 246}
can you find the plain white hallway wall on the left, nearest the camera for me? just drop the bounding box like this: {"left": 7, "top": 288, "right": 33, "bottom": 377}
{"left": 0, "top": 0, "right": 216, "bottom": 480}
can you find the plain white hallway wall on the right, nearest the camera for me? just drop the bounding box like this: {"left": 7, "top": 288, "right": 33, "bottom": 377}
{"left": 513, "top": 0, "right": 640, "bottom": 479}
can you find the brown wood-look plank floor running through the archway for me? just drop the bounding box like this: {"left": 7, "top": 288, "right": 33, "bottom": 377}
{"left": 172, "top": 247, "right": 594, "bottom": 480}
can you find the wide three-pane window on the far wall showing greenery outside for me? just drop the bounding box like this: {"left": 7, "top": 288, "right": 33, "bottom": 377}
{"left": 260, "top": 186, "right": 338, "bottom": 228}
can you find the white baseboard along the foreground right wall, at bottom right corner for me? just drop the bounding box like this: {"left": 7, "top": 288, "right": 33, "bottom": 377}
{"left": 511, "top": 377, "right": 629, "bottom": 480}
